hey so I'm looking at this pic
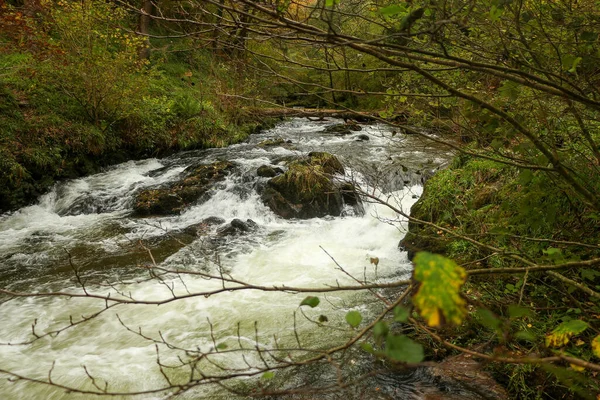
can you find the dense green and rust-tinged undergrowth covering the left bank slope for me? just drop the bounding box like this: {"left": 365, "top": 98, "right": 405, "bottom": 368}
{"left": 0, "top": 2, "right": 271, "bottom": 212}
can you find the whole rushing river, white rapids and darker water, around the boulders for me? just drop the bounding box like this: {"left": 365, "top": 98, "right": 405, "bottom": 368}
{"left": 0, "top": 119, "right": 447, "bottom": 399}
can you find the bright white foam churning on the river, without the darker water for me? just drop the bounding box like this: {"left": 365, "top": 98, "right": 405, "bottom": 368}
{"left": 0, "top": 120, "right": 446, "bottom": 399}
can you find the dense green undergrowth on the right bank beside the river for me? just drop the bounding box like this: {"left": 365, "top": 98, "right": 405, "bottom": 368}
{"left": 403, "top": 155, "right": 600, "bottom": 399}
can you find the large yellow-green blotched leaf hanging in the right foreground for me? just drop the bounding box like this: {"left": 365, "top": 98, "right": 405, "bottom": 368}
{"left": 413, "top": 252, "right": 467, "bottom": 327}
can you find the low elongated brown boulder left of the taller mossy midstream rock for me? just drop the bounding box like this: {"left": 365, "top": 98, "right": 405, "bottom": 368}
{"left": 133, "top": 161, "right": 234, "bottom": 216}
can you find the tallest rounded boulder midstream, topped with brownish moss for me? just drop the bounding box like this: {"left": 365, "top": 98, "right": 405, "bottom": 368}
{"left": 262, "top": 152, "right": 358, "bottom": 219}
